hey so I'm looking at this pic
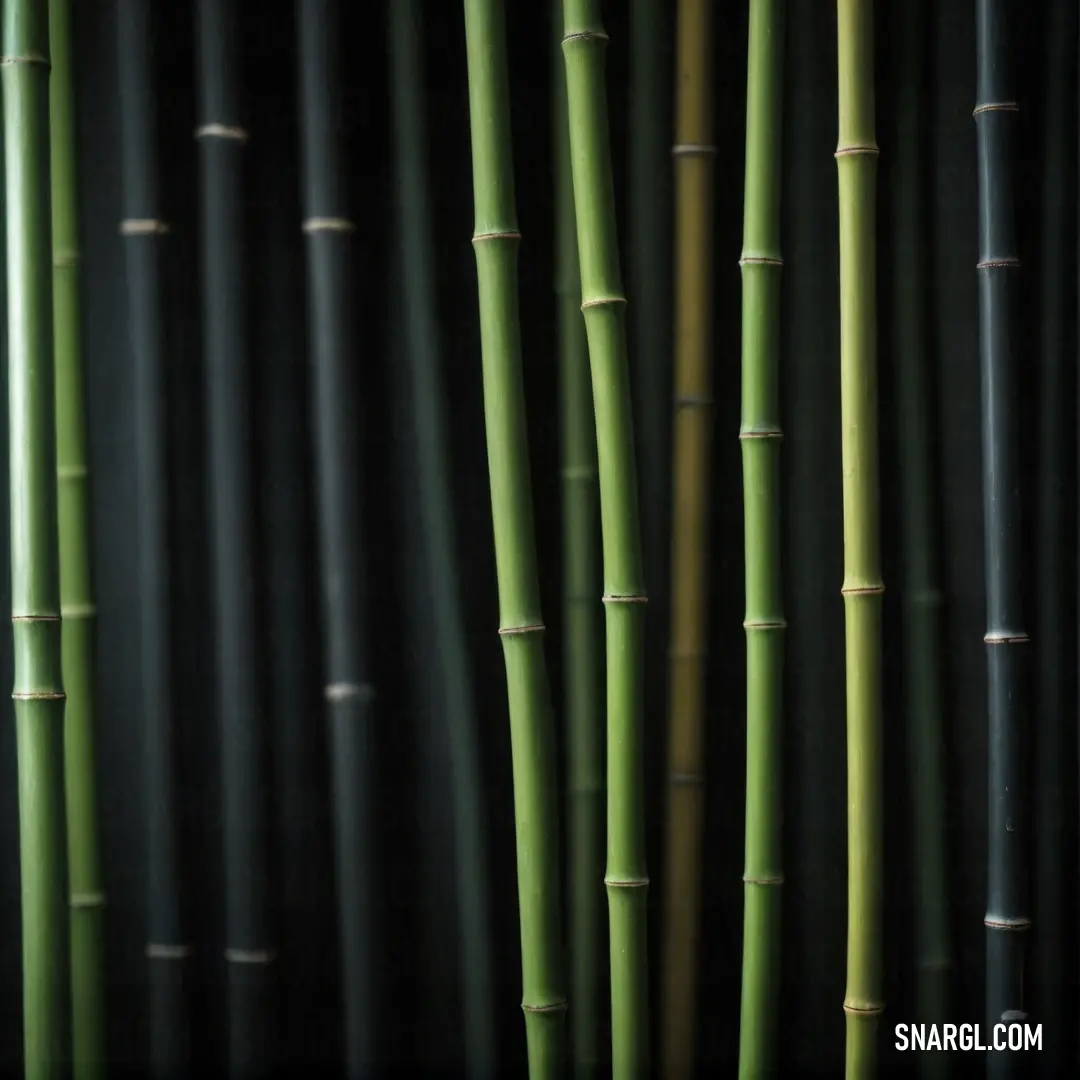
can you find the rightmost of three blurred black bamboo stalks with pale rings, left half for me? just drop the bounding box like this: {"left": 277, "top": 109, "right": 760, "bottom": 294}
{"left": 296, "top": 0, "right": 374, "bottom": 1078}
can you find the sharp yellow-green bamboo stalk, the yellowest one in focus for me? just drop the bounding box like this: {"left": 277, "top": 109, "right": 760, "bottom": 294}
{"left": 836, "top": 0, "right": 885, "bottom": 1080}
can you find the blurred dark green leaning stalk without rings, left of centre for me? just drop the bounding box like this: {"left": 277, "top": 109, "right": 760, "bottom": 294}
{"left": 390, "top": 0, "right": 496, "bottom": 1080}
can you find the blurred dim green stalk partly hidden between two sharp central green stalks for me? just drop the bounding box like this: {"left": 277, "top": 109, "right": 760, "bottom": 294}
{"left": 552, "top": 0, "right": 607, "bottom": 1080}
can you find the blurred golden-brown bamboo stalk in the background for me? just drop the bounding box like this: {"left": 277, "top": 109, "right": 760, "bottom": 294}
{"left": 662, "top": 0, "right": 716, "bottom": 1080}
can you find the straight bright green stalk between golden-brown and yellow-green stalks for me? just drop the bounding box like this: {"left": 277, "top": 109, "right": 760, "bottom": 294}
{"left": 739, "top": 0, "right": 787, "bottom": 1080}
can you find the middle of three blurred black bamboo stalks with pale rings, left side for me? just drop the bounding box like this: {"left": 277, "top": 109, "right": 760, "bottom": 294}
{"left": 195, "top": 0, "right": 274, "bottom": 1077}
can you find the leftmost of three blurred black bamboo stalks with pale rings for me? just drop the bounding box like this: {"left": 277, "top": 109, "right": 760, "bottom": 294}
{"left": 117, "top": 0, "right": 190, "bottom": 1080}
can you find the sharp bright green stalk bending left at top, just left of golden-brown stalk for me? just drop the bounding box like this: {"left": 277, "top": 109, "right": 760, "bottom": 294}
{"left": 563, "top": 0, "right": 649, "bottom": 1080}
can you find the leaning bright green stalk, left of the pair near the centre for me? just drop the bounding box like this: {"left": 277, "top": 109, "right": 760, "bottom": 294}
{"left": 464, "top": 0, "right": 566, "bottom": 1080}
